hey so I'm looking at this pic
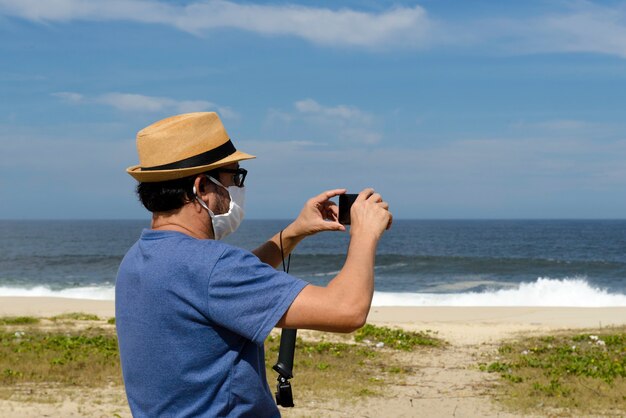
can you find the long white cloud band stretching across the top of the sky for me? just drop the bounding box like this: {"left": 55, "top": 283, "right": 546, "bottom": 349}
{"left": 0, "top": 0, "right": 626, "bottom": 58}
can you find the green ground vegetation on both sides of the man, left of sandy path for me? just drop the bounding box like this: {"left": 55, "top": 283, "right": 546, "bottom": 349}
{"left": 0, "top": 313, "right": 446, "bottom": 402}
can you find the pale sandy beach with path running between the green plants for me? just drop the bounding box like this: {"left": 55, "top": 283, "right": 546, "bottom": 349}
{"left": 0, "top": 297, "right": 626, "bottom": 417}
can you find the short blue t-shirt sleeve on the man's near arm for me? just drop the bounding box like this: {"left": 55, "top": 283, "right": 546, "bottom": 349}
{"left": 207, "top": 247, "right": 308, "bottom": 345}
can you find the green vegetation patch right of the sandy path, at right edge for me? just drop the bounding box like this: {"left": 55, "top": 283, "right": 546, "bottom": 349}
{"left": 480, "top": 327, "right": 626, "bottom": 416}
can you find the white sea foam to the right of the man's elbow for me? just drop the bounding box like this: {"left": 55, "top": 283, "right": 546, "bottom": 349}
{"left": 372, "top": 278, "right": 626, "bottom": 307}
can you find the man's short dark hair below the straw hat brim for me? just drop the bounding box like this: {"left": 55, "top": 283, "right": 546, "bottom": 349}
{"left": 137, "top": 170, "right": 218, "bottom": 212}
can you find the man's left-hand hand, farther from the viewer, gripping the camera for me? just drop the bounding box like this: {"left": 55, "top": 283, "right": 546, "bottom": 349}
{"left": 292, "top": 189, "right": 346, "bottom": 236}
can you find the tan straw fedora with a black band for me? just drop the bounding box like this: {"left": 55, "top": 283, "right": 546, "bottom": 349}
{"left": 126, "top": 112, "right": 255, "bottom": 183}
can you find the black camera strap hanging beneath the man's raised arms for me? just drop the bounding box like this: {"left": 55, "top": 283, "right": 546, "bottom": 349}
{"left": 273, "top": 231, "right": 298, "bottom": 408}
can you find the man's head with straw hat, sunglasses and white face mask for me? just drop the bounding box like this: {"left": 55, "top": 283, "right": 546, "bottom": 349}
{"left": 126, "top": 112, "right": 255, "bottom": 239}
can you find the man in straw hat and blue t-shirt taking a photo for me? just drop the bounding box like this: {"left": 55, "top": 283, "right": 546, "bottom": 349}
{"left": 115, "top": 112, "right": 391, "bottom": 417}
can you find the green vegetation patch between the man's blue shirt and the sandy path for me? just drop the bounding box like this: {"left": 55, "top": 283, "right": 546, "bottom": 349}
{"left": 266, "top": 324, "right": 446, "bottom": 401}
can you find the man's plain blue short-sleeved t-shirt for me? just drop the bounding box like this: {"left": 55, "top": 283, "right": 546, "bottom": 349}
{"left": 115, "top": 230, "right": 307, "bottom": 417}
